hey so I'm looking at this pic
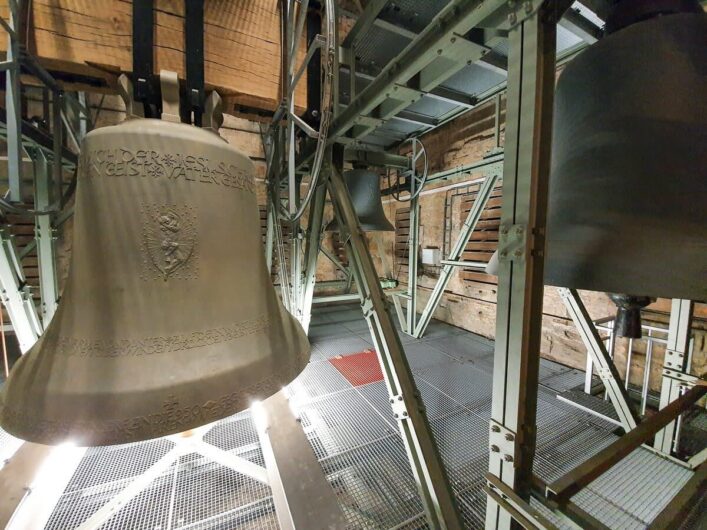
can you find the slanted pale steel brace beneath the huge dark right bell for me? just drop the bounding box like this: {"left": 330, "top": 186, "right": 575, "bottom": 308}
{"left": 558, "top": 287, "right": 639, "bottom": 432}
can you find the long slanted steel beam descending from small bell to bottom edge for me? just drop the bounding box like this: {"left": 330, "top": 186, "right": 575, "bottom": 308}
{"left": 328, "top": 145, "right": 463, "bottom": 529}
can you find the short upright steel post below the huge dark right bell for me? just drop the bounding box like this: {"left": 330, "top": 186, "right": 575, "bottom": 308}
{"left": 653, "top": 298, "right": 694, "bottom": 455}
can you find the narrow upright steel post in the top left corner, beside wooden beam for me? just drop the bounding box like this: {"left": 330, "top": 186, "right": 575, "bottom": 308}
{"left": 5, "top": 0, "right": 24, "bottom": 202}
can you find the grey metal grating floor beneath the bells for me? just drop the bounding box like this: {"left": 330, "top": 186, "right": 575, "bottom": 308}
{"left": 0, "top": 306, "right": 704, "bottom": 530}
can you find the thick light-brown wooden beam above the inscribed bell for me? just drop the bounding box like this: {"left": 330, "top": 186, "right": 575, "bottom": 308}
{"left": 0, "top": 0, "right": 306, "bottom": 112}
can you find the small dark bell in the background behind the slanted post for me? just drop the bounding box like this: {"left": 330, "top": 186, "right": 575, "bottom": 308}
{"left": 326, "top": 169, "right": 395, "bottom": 232}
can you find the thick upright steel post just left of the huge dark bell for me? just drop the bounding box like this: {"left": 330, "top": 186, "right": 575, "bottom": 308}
{"left": 486, "top": 1, "right": 559, "bottom": 528}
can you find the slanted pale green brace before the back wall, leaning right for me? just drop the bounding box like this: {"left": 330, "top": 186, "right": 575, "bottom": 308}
{"left": 410, "top": 166, "right": 501, "bottom": 338}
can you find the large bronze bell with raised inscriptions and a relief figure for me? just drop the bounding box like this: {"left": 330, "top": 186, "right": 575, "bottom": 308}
{"left": 0, "top": 76, "right": 310, "bottom": 445}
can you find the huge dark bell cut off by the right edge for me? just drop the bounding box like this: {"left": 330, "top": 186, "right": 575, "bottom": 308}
{"left": 545, "top": 0, "right": 707, "bottom": 300}
